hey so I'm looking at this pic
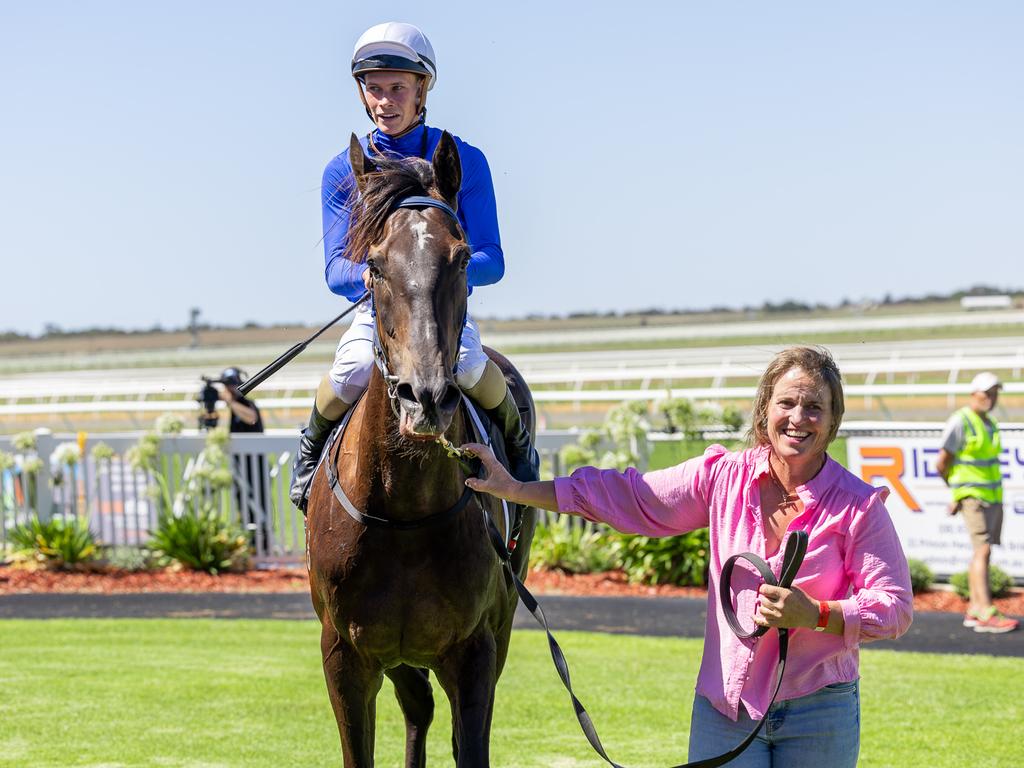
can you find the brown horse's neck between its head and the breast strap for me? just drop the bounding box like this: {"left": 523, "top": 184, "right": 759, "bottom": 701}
{"left": 346, "top": 370, "right": 465, "bottom": 518}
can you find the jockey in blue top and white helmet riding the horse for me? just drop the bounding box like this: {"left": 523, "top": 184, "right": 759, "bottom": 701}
{"left": 291, "top": 22, "right": 538, "bottom": 511}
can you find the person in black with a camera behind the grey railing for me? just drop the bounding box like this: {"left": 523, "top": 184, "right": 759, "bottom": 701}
{"left": 216, "top": 368, "right": 271, "bottom": 549}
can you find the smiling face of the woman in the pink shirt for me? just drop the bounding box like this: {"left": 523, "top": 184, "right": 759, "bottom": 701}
{"left": 766, "top": 368, "right": 833, "bottom": 467}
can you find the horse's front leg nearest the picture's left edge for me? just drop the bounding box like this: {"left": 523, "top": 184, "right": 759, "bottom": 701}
{"left": 321, "top": 616, "right": 384, "bottom": 768}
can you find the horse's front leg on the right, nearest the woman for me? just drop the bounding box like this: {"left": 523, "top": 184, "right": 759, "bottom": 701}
{"left": 437, "top": 632, "right": 498, "bottom": 768}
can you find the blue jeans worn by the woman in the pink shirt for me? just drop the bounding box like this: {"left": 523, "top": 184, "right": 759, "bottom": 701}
{"left": 689, "top": 680, "right": 860, "bottom": 768}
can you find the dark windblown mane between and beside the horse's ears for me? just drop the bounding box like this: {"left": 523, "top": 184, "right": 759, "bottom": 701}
{"left": 345, "top": 158, "right": 434, "bottom": 264}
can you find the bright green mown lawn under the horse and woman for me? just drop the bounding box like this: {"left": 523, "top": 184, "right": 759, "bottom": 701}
{"left": 0, "top": 620, "right": 1024, "bottom": 768}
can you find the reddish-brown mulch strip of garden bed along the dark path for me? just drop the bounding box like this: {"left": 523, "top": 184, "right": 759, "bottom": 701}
{"left": 0, "top": 565, "right": 1024, "bottom": 615}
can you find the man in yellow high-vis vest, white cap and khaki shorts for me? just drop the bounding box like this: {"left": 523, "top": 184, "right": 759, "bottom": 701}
{"left": 936, "top": 372, "right": 1018, "bottom": 633}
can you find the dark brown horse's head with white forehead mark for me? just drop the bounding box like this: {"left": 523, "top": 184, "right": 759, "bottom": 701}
{"left": 348, "top": 133, "right": 470, "bottom": 439}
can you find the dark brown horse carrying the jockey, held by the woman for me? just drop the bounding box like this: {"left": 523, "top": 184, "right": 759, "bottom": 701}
{"left": 307, "top": 133, "right": 536, "bottom": 768}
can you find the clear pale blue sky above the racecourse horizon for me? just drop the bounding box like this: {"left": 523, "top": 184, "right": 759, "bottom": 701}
{"left": 0, "top": 0, "right": 1024, "bottom": 333}
